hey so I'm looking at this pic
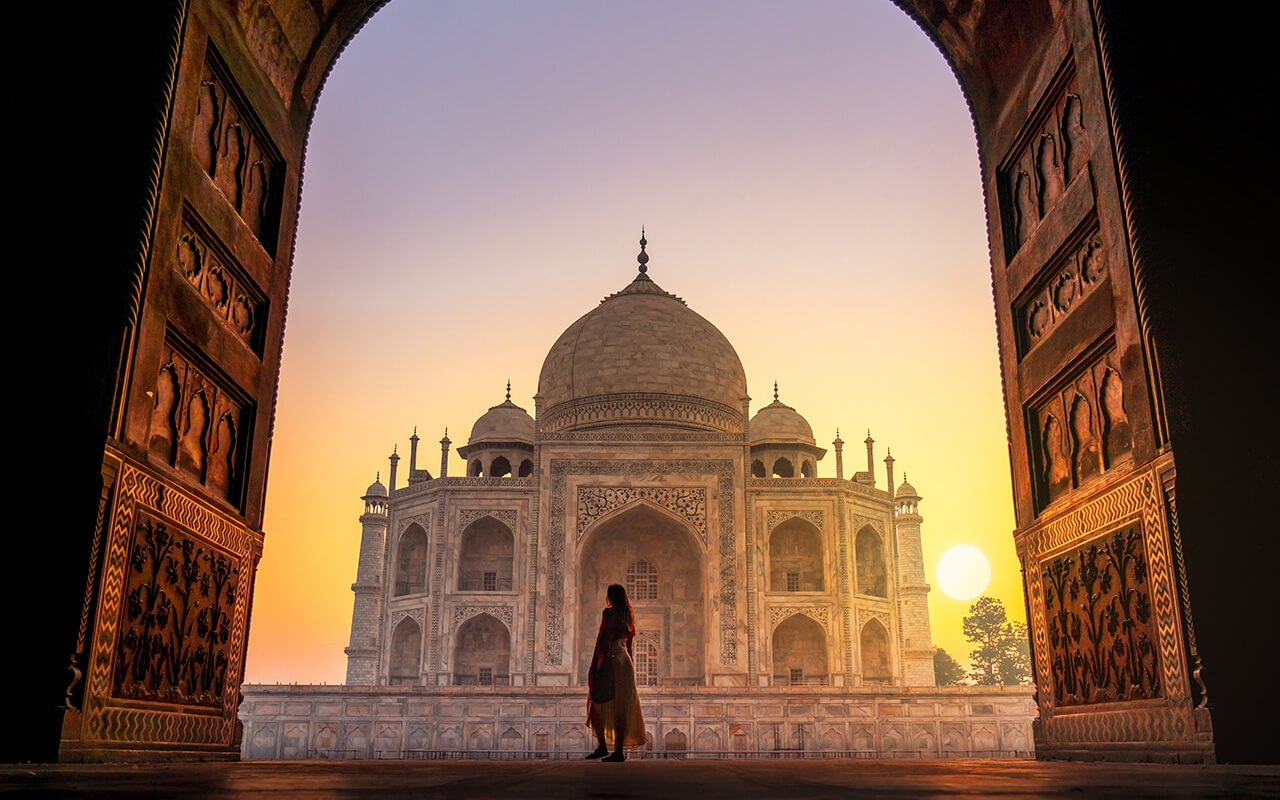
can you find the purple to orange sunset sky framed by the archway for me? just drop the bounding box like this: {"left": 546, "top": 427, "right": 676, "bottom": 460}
{"left": 238, "top": 0, "right": 1023, "bottom": 684}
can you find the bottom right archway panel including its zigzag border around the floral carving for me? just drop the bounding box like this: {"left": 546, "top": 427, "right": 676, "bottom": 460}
{"left": 1016, "top": 457, "right": 1201, "bottom": 746}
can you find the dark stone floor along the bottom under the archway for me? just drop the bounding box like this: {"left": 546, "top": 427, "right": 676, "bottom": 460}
{"left": 0, "top": 759, "right": 1280, "bottom": 800}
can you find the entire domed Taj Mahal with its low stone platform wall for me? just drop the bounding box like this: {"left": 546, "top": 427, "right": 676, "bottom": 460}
{"left": 241, "top": 237, "right": 1036, "bottom": 758}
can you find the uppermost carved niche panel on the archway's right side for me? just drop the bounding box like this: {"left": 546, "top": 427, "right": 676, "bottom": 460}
{"left": 998, "top": 63, "right": 1091, "bottom": 256}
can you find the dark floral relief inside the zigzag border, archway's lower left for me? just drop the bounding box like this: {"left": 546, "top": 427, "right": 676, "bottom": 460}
{"left": 113, "top": 516, "right": 239, "bottom": 707}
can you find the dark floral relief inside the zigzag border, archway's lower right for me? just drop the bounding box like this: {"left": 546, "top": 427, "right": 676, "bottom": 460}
{"left": 1041, "top": 525, "right": 1161, "bottom": 708}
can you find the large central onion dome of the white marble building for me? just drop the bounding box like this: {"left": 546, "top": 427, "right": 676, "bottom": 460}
{"left": 538, "top": 264, "right": 746, "bottom": 433}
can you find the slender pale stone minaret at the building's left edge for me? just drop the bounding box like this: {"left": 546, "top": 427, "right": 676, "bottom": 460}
{"left": 346, "top": 479, "right": 388, "bottom": 686}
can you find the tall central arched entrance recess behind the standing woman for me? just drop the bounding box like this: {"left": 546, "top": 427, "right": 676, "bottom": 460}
{"left": 577, "top": 503, "right": 708, "bottom": 685}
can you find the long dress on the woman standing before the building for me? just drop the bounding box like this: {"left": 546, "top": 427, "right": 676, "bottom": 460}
{"left": 586, "top": 608, "right": 646, "bottom": 749}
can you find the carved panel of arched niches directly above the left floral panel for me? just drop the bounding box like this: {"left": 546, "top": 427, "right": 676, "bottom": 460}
{"left": 148, "top": 338, "right": 253, "bottom": 507}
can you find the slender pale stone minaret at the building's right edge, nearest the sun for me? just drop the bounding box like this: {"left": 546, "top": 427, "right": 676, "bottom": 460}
{"left": 893, "top": 472, "right": 937, "bottom": 686}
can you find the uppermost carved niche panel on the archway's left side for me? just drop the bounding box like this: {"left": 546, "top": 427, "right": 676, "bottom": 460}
{"left": 191, "top": 44, "right": 284, "bottom": 255}
